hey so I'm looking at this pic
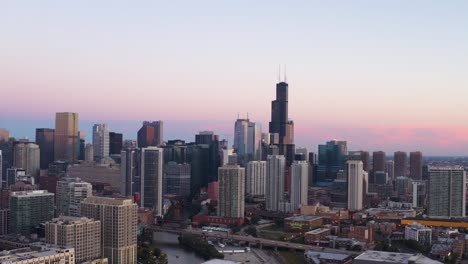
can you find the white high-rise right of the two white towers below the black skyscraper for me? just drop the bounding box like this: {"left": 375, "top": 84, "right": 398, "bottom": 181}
{"left": 290, "top": 161, "right": 309, "bottom": 211}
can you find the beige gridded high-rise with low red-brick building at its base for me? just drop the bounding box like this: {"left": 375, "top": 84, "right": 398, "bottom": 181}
{"left": 218, "top": 165, "right": 245, "bottom": 218}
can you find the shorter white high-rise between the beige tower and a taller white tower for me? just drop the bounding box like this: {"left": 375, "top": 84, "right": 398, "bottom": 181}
{"left": 245, "top": 161, "right": 267, "bottom": 196}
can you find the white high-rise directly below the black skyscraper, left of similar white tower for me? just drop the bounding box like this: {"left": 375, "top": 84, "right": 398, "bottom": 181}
{"left": 265, "top": 155, "right": 286, "bottom": 211}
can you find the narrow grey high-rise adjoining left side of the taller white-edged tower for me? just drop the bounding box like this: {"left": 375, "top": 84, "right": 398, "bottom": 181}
{"left": 120, "top": 148, "right": 141, "bottom": 196}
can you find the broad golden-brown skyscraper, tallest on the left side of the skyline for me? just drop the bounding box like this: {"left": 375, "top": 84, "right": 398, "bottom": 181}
{"left": 54, "top": 112, "right": 79, "bottom": 162}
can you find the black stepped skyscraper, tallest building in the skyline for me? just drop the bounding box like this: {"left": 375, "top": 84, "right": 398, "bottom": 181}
{"left": 269, "top": 82, "right": 295, "bottom": 166}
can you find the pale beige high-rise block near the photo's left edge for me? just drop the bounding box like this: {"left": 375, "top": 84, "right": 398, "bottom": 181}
{"left": 13, "top": 142, "right": 40, "bottom": 176}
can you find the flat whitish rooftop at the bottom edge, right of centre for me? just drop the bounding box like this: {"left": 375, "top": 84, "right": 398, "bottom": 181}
{"left": 353, "top": 250, "right": 441, "bottom": 264}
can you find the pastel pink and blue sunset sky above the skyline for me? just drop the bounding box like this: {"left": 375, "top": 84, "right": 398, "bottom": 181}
{"left": 0, "top": 0, "right": 468, "bottom": 156}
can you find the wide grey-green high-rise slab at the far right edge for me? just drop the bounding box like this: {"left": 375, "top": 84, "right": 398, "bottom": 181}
{"left": 427, "top": 167, "right": 466, "bottom": 218}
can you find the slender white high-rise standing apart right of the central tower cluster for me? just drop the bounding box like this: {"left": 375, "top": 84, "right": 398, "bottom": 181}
{"left": 347, "top": 160, "right": 364, "bottom": 211}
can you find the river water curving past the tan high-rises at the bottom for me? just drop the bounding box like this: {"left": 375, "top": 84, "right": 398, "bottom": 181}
{"left": 153, "top": 232, "right": 205, "bottom": 264}
